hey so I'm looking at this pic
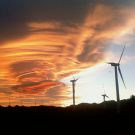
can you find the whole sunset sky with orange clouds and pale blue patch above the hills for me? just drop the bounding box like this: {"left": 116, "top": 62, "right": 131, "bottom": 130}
{"left": 0, "top": 0, "right": 135, "bottom": 106}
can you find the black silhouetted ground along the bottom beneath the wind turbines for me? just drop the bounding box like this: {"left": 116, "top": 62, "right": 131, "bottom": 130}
{"left": 0, "top": 98, "right": 135, "bottom": 135}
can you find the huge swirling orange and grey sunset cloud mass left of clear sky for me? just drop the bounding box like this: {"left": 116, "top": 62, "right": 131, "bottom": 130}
{"left": 0, "top": 0, "right": 135, "bottom": 106}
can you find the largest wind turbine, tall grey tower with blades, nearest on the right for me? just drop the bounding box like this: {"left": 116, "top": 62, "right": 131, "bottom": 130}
{"left": 107, "top": 46, "right": 126, "bottom": 103}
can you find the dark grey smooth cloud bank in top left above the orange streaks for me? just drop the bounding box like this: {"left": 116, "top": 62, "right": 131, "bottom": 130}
{"left": 0, "top": 0, "right": 93, "bottom": 42}
